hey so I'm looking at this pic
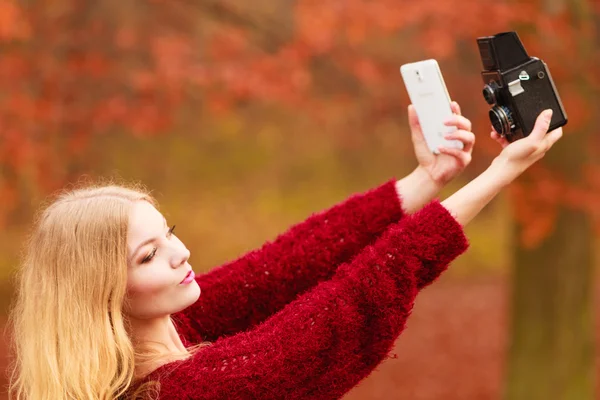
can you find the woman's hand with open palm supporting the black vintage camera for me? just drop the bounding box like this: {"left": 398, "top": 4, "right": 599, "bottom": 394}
{"left": 491, "top": 110, "right": 563, "bottom": 183}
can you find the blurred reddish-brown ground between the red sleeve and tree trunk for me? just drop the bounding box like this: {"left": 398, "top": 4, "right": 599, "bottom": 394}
{"left": 0, "top": 278, "right": 600, "bottom": 400}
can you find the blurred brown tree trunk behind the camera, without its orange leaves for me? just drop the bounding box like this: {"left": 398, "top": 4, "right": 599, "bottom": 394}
{"left": 505, "top": 0, "right": 595, "bottom": 400}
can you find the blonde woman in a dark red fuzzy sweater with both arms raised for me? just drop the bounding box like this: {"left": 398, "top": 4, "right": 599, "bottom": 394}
{"left": 11, "top": 104, "right": 562, "bottom": 400}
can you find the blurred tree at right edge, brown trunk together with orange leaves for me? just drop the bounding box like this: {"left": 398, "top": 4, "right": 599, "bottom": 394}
{"left": 506, "top": 0, "right": 600, "bottom": 400}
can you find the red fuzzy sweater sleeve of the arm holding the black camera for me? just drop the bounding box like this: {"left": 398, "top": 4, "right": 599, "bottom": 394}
{"left": 149, "top": 202, "right": 467, "bottom": 400}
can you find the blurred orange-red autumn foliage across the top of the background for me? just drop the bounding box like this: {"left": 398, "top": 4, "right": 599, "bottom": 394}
{"left": 0, "top": 0, "right": 600, "bottom": 246}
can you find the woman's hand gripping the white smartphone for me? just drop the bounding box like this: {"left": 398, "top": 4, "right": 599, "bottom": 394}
{"left": 408, "top": 101, "right": 475, "bottom": 187}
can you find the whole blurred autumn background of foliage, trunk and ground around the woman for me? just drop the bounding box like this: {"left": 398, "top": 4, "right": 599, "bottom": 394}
{"left": 0, "top": 0, "right": 600, "bottom": 400}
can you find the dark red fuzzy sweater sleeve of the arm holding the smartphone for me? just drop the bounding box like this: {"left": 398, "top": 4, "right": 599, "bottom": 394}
{"left": 174, "top": 180, "right": 404, "bottom": 341}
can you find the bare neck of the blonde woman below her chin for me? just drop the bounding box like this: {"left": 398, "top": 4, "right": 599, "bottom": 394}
{"left": 130, "top": 315, "right": 189, "bottom": 377}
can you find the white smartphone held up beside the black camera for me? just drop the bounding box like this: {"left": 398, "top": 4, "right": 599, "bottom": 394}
{"left": 400, "top": 59, "right": 464, "bottom": 154}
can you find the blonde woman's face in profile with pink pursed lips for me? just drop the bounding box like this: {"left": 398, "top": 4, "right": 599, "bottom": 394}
{"left": 125, "top": 201, "right": 200, "bottom": 319}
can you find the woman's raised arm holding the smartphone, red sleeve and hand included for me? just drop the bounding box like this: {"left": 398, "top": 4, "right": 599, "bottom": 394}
{"left": 179, "top": 103, "right": 474, "bottom": 341}
